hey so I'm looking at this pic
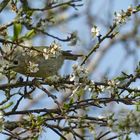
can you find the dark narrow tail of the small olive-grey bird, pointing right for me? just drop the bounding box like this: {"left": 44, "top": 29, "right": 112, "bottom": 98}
{"left": 62, "top": 51, "right": 83, "bottom": 60}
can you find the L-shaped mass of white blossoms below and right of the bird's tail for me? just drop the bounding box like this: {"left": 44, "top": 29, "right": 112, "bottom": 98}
{"left": 70, "top": 65, "right": 122, "bottom": 98}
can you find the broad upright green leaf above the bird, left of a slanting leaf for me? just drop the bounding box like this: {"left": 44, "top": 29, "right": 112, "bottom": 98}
{"left": 13, "top": 23, "right": 22, "bottom": 40}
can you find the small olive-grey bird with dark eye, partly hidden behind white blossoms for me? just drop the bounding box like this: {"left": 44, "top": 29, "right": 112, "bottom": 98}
{"left": 0, "top": 43, "right": 82, "bottom": 78}
